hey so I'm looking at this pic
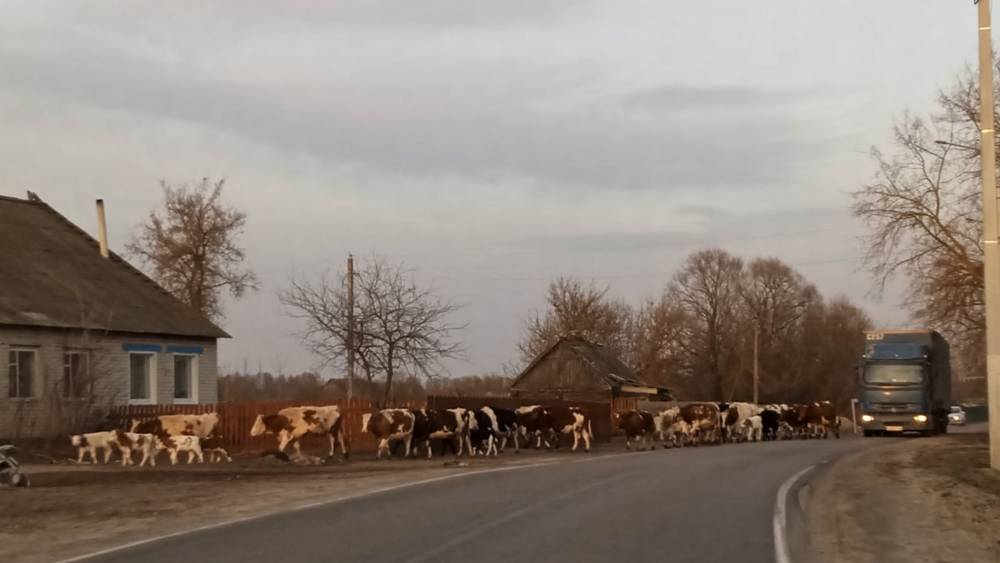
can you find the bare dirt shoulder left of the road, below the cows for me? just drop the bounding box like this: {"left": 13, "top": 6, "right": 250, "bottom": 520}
{"left": 0, "top": 446, "right": 608, "bottom": 562}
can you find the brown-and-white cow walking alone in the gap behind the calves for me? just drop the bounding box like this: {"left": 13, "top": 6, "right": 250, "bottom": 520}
{"left": 250, "top": 405, "right": 349, "bottom": 458}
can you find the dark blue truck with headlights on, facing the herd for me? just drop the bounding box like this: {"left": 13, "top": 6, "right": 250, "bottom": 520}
{"left": 858, "top": 329, "right": 951, "bottom": 436}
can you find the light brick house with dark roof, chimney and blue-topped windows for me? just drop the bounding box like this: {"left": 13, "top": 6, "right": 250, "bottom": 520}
{"left": 0, "top": 192, "right": 229, "bottom": 438}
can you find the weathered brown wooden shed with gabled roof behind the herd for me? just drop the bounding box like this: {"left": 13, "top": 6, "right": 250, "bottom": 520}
{"left": 510, "top": 336, "right": 670, "bottom": 401}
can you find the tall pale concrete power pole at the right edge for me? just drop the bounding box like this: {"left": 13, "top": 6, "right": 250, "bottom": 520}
{"left": 978, "top": 0, "right": 1000, "bottom": 470}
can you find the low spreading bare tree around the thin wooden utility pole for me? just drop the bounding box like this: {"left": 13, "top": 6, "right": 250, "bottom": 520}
{"left": 279, "top": 258, "right": 464, "bottom": 403}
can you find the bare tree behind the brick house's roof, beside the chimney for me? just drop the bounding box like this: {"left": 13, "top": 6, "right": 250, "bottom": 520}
{"left": 126, "top": 178, "right": 257, "bottom": 320}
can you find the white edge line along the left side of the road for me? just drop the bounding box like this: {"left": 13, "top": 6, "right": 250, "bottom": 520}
{"left": 56, "top": 453, "right": 629, "bottom": 563}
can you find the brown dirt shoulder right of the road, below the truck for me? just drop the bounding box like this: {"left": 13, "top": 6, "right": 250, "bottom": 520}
{"left": 808, "top": 434, "right": 1000, "bottom": 563}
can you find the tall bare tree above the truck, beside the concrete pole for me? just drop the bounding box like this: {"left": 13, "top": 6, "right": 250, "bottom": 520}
{"left": 853, "top": 59, "right": 1000, "bottom": 390}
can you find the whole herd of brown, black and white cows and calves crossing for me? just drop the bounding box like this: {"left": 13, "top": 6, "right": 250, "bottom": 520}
{"left": 64, "top": 401, "right": 840, "bottom": 466}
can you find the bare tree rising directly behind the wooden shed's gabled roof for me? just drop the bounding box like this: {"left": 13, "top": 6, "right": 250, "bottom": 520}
{"left": 519, "top": 277, "right": 632, "bottom": 364}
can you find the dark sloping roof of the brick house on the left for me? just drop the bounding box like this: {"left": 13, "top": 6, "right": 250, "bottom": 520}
{"left": 0, "top": 192, "right": 229, "bottom": 338}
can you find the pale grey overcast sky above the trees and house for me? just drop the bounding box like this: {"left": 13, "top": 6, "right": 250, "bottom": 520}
{"left": 0, "top": 0, "right": 977, "bottom": 375}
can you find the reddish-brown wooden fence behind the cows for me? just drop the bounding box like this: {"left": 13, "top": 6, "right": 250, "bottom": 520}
{"left": 109, "top": 396, "right": 636, "bottom": 453}
